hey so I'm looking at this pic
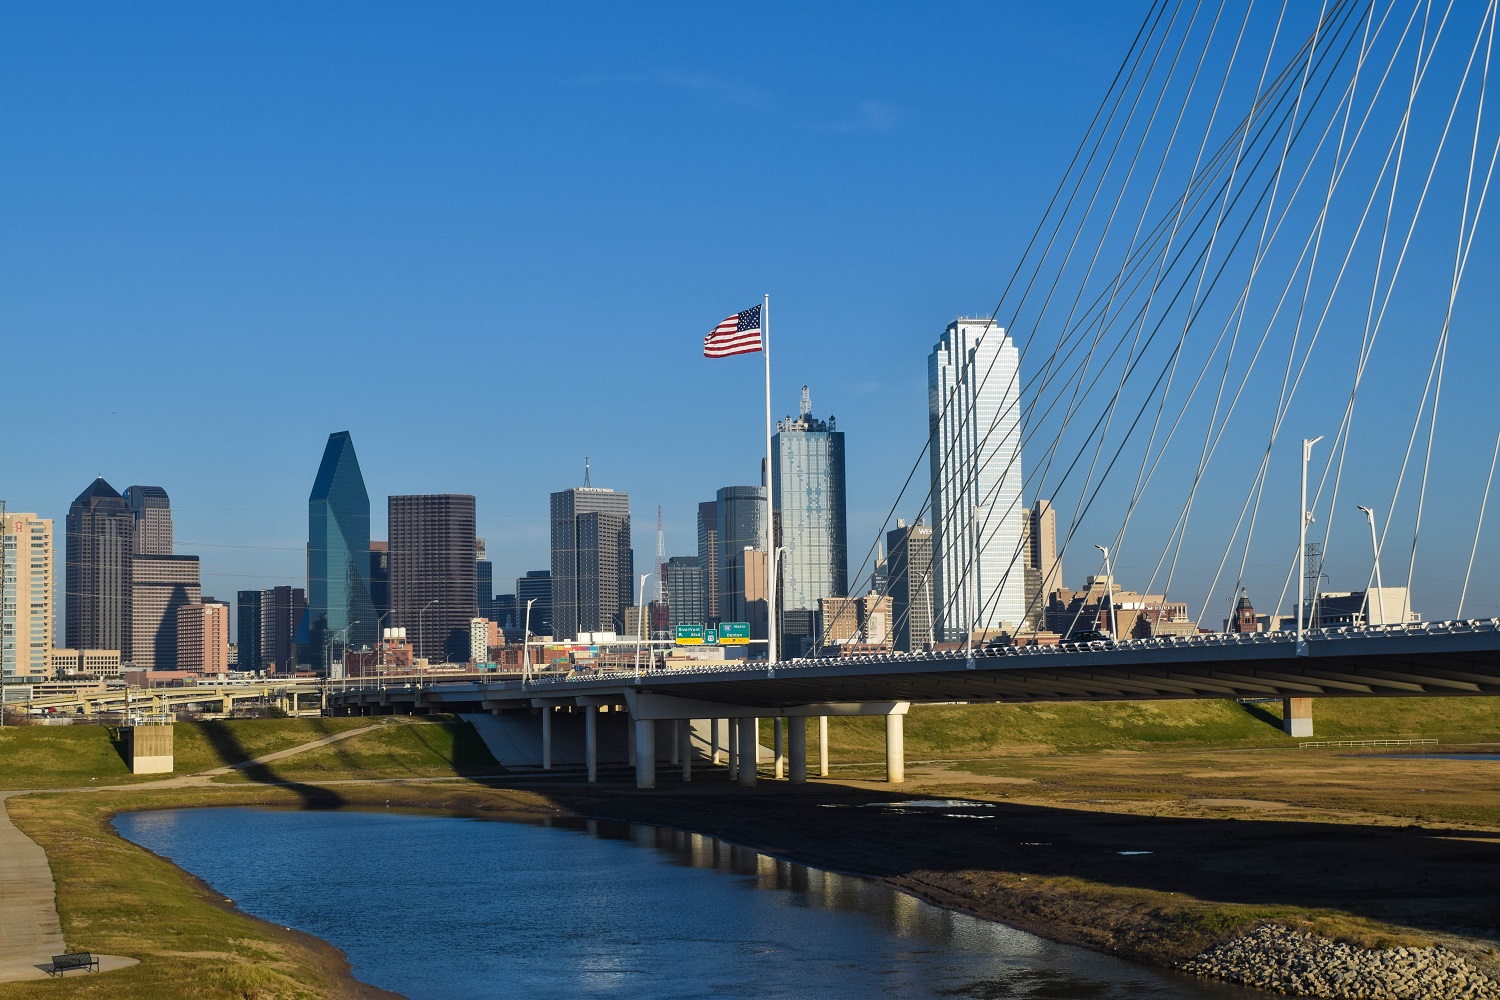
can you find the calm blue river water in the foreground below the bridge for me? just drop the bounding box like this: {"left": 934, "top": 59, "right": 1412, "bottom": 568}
{"left": 116, "top": 808, "right": 1266, "bottom": 1000}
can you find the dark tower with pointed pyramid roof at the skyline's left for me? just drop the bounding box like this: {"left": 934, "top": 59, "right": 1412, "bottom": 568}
{"left": 63, "top": 477, "right": 135, "bottom": 655}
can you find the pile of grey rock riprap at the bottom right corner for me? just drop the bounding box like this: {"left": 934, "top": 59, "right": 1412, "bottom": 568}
{"left": 1178, "top": 924, "right": 1500, "bottom": 1000}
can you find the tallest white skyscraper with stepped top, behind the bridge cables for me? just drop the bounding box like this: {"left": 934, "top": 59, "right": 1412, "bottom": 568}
{"left": 927, "top": 319, "right": 1028, "bottom": 642}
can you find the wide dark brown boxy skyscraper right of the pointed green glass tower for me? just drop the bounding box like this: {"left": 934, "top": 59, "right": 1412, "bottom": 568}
{"left": 389, "top": 493, "right": 476, "bottom": 663}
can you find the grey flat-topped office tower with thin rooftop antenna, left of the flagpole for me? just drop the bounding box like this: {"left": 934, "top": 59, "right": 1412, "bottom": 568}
{"left": 551, "top": 486, "right": 635, "bottom": 639}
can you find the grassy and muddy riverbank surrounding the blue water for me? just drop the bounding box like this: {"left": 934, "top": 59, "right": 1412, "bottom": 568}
{"left": 0, "top": 707, "right": 1500, "bottom": 997}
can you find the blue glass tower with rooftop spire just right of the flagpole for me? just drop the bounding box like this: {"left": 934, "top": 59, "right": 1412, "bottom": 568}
{"left": 780, "top": 385, "right": 849, "bottom": 610}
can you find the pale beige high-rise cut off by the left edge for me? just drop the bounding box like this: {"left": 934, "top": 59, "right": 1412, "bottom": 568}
{"left": 0, "top": 502, "right": 57, "bottom": 678}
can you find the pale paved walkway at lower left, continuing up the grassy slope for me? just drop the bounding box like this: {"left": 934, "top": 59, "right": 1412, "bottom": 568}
{"left": 0, "top": 723, "right": 389, "bottom": 982}
